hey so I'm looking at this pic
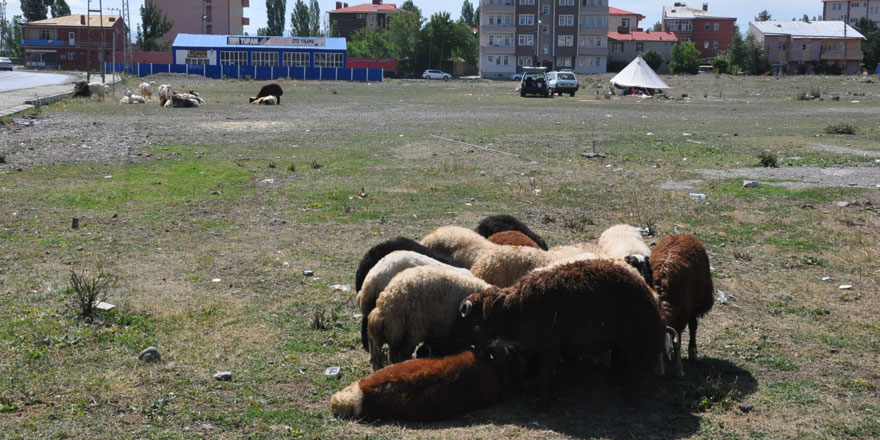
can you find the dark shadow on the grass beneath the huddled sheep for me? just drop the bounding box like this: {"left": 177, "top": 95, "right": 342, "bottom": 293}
{"left": 364, "top": 358, "right": 758, "bottom": 440}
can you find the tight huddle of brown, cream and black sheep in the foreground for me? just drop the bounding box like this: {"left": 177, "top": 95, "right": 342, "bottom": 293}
{"left": 330, "top": 215, "right": 714, "bottom": 421}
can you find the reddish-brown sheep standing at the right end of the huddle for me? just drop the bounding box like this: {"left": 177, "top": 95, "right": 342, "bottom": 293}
{"left": 651, "top": 234, "right": 715, "bottom": 376}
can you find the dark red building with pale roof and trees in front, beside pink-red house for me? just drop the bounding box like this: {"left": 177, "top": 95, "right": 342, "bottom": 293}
{"left": 661, "top": 2, "right": 736, "bottom": 60}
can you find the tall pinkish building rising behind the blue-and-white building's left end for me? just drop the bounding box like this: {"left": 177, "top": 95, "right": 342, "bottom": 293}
{"left": 148, "top": 0, "right": 251, "bottom": 43}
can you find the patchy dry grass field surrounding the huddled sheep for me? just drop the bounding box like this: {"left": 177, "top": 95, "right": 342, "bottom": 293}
{"left": 0, "top": 75, "right": 880, "bottom": 439}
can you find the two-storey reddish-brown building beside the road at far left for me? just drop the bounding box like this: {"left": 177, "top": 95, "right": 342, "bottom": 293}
{"left": 21, "top": 15, "right": 128, "bottom": 70}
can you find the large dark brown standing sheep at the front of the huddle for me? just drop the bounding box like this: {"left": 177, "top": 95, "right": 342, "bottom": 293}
{"left": 450, "top": 260, "right": 677, "bottom": 395}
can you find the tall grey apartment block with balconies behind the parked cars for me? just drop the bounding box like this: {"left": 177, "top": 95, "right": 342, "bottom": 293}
{"left": 480, "top": 0, "right": 608, "bottom": 78}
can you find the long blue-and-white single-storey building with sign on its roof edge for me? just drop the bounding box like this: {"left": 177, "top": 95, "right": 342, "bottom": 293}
{"left": 171, "top": 34, "right": 346, "bottom": 68}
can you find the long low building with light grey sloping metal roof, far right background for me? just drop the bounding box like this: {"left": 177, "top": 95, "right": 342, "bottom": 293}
{"left": 749, "top": 21, "right": 865, "bottom": 75}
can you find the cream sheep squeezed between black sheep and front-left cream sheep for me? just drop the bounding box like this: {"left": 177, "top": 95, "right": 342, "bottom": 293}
{"left": 357, "top": 251, "right": 472, "bottom": 350}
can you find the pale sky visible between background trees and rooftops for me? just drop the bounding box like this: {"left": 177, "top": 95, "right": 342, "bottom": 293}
{"left": 0, "top": 0, "right": 822, "bottom": 35}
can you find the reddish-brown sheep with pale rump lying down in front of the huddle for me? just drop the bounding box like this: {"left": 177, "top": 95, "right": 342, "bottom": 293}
{"left": 330, "top": 344, "right": 518, "bottom": 422}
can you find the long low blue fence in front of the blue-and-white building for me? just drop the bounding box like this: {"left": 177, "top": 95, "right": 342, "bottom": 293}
{"left": 104, "top": 63, "right": 384, "bottom": 82}
